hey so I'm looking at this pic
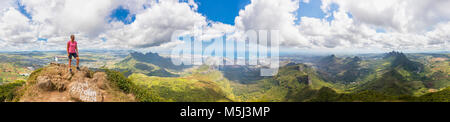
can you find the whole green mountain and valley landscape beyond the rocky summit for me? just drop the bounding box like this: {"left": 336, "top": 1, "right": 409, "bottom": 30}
{"left": 0, "top": 51, "right": 450, "bottom": 102}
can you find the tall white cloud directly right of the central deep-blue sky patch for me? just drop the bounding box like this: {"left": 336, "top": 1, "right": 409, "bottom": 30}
{"left": 235, "top": 0, "right": 308, "bottom": 46}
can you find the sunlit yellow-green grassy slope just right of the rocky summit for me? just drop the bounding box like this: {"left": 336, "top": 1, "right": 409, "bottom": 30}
{"left": 105, "top": 65, "right": 233, "bottom": 102}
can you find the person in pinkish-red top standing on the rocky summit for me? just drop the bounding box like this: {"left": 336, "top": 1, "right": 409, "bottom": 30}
{"left": 67, "top": 35, "right": 80, "bottom": 72}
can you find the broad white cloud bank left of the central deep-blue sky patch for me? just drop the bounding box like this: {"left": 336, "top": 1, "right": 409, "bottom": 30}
{"left": 0, "top": 0, "right": 212, "bottom": 50}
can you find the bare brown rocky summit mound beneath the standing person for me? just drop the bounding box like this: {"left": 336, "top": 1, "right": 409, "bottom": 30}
{"left": 20, "top": 63, "right": 134, "bottom": 102}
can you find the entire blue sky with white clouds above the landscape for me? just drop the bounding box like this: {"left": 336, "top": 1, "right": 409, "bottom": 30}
{"left": 0, "top": 0, "right": 450, "bottom": 52}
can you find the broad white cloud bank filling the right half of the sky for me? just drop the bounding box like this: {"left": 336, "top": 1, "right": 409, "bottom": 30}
{"left": 230, "top": 0, "right": 450, "bottom": 50}
